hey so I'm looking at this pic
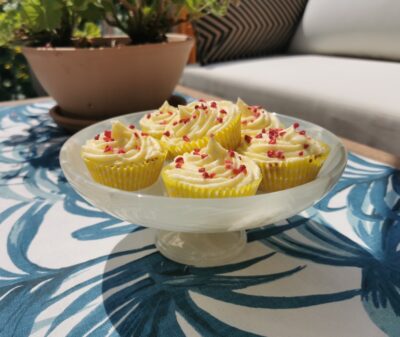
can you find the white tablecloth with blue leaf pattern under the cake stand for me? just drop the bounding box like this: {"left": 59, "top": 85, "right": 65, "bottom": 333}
{"left": 0, "top": 98, "right": 400, "bottom": 337}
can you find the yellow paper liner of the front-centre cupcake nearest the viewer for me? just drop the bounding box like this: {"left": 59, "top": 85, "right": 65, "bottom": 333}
{"left": 161, "top": 166, "right": 262, "bottom": 199}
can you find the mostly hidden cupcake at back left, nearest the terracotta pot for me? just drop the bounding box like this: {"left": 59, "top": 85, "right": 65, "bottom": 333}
{"left": 139, "top": 101, "right": 178, "bottom": 139}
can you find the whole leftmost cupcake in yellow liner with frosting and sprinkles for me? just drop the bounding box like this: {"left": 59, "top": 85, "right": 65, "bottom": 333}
{"left": 81, "top": 121, "right": 166, "bottom": 191}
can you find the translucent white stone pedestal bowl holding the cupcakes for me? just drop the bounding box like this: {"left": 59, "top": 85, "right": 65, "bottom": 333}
{"left": 60, "top": 111, "right": 347, "bottom": 266}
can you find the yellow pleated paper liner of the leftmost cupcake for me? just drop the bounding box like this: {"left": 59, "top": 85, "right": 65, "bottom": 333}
{"left": 84, "top": 152, "right": 167, "bottom": 191}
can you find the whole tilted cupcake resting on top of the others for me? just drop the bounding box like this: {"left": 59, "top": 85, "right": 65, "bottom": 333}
{"left": 161, "top": 101, "right": 240, "bottom": 158}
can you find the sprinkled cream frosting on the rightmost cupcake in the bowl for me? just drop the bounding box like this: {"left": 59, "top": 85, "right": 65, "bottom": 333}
{"left": 238, "top": 123, "right": 326, "bottom": 162}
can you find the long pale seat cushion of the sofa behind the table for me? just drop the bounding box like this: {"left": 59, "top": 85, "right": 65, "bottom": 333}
{"left": 181, "top": 55, "right": 400, "bottom": 155}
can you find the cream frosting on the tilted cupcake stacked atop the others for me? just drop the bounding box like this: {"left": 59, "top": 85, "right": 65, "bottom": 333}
{"left": 161, "top": 101, "right": 239, "bottom": 145}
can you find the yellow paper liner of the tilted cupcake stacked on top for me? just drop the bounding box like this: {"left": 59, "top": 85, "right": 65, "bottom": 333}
{"left": 160, "top": 115, "right": 240, "bottom": 159}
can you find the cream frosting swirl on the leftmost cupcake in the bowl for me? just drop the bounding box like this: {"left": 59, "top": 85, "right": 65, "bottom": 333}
{"left": 81, "top": 121, "right": 163, "bottom": 165}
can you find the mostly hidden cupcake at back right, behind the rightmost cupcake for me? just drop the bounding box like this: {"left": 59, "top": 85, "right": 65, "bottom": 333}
{"left": 236, "top": 98, "right": 283, "bottom": 137}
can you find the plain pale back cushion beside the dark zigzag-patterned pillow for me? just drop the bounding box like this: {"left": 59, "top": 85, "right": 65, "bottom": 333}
{"left": 289, "top": 0, "right": 400, "bottom": 60}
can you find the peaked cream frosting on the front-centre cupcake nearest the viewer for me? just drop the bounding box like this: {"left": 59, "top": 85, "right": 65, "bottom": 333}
{"left": 165, "top": 138, "right": 261, "bottom": 188}
